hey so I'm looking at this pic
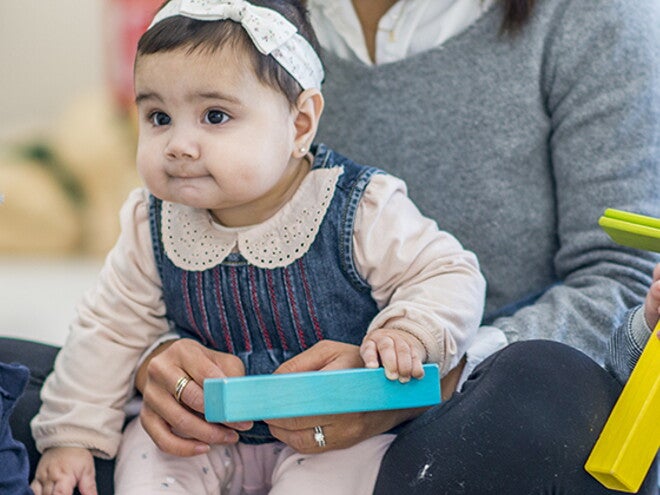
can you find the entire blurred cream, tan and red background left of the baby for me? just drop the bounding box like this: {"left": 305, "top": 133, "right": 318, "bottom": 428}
{"left": 0, "top": 0, "right": 161, "bottom": 344}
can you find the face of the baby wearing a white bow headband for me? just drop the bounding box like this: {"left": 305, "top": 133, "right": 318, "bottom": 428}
{"left": 135, "top": 48, "right": 300, "bottom": 226}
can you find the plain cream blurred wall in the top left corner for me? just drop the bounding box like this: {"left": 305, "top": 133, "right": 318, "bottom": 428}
{"left": 0, "top": 0, "right": 104, "bottom": 137}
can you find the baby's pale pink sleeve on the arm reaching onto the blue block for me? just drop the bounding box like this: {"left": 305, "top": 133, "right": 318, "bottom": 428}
{"left": 353, "top": 174, "right": 485, "bottom": 374}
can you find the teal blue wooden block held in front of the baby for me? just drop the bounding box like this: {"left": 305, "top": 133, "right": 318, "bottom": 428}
{"left": 204, "top": 364, "right": 440, "bottom": 423}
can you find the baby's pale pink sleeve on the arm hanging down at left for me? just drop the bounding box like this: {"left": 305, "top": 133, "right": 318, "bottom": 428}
{"left": 31, "top": 190, "right": 168, "bottom": 458}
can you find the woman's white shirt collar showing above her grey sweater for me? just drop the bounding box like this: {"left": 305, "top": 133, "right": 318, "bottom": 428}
{"left": 308, "top": 0, "right": 493, "bottom": 65}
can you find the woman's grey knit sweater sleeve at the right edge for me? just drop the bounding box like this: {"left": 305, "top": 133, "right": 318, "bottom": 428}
{"left": 491, "top": 0, "right": 660, "bottom": 371}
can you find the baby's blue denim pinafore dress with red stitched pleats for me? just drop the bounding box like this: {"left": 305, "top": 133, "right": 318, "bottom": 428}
{"left": 150, "top": 145, "right": 382, "bottom": 443}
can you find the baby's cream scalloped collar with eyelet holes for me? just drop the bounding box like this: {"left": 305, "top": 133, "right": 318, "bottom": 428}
{"left": 161, "top": 167, "right": 343, "bottom": 271}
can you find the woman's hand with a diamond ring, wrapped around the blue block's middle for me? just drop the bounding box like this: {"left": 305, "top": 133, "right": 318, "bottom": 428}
{"left": 266, "top": 340, "right": 434, "bottom": 454}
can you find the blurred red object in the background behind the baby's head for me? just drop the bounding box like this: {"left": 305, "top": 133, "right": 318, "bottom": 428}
{"left": 103, "top": 0, "right": 164, "bottom": 111}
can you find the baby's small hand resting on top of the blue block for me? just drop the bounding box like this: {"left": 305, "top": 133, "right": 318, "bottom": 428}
{"left": 360, "top": 328, "right": 426, "bottom": 383}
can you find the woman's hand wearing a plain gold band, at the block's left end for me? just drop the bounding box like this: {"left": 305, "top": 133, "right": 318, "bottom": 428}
{"left": 135, "top": 339, "right": 252, "bottom": 456}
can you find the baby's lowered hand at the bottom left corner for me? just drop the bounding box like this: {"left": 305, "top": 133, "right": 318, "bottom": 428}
{"left": 30, "top": 447, "right": 97, "bottom": 495}
